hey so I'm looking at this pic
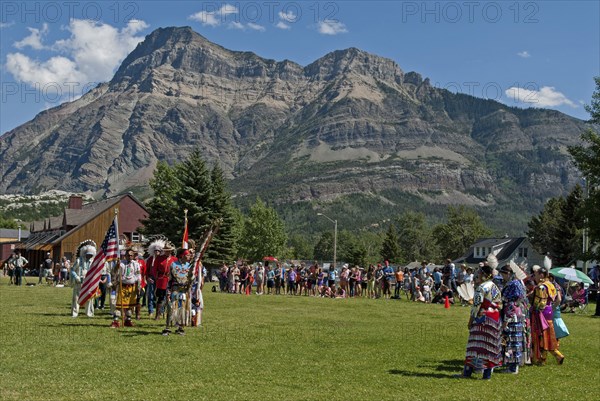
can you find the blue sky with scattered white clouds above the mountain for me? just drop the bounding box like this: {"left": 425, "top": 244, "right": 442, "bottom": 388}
{"left": 0, "top": 1, "right": 600, "bottom": 133}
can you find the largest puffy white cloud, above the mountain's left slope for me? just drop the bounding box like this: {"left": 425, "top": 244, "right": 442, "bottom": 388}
{"left": 6, "top": 19, "right": 148, "bottom": 93}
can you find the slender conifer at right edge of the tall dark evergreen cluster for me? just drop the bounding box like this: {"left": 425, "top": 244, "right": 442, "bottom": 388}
{"left": 204, "top": 164, "right": 239, "bottom": 267}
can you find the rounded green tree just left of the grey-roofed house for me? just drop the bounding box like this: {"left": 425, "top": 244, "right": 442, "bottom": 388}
{"left": 433, "top": 205, "right": 491, "bottom": 259}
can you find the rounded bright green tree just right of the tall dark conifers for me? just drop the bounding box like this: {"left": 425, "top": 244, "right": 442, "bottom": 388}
{"left": 240, "top": 199, "right": 287, "bottom": 261}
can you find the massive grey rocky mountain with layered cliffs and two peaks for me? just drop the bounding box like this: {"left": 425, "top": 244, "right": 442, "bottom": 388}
{"left": 0, "top": 27, "right": 588, "bottom": 233}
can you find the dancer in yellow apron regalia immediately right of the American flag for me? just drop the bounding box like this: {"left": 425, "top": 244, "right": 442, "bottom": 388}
{"left": 111, "top": 248, "right": 142, "bottom": 328}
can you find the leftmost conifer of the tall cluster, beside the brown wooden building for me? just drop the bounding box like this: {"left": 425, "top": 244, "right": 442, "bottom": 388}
{"left": 142, "top": 162, "right": 182, "bottom": 241}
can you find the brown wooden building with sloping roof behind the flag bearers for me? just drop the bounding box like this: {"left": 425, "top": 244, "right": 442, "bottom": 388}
{"left": 17, "top": 194, "right": 148, "bottom": 268}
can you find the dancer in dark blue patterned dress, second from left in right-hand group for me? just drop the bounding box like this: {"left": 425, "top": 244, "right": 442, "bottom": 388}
{"left": 500, "top": 265, "right": 527, "bottom": 374}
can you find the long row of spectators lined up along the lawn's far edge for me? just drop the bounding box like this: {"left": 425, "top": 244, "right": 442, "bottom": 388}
{"left": 211, "top": 260, "right": 473, "bottom": 303}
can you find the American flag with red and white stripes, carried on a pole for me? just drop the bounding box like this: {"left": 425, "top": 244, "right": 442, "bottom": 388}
{"left": 79, "top": 216, "right": 119, "bottom": 305}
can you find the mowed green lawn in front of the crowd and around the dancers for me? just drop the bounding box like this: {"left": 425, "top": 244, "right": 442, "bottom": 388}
{"left": 0, "top": 278, "right": 600, "bottom": 400}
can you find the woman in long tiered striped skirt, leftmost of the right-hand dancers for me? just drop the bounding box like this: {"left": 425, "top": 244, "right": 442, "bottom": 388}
{"left": 457, "top": 257, "right": 502, "bottom": 380}
